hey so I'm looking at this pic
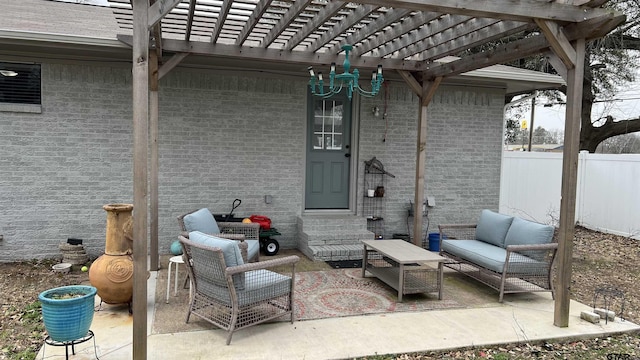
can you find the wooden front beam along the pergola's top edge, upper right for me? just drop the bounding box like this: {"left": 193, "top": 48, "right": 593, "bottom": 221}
{"left": 358, "top": 0, "right": 609, "bottom": 22}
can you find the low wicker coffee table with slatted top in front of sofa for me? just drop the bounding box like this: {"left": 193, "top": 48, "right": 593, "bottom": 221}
{"left": 362, "top": 240, "right": 446, "bottom": 301}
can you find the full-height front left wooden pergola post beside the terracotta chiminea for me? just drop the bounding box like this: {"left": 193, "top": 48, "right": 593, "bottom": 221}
{"left": 132, "top": 0, "right": 149, "bottom": 360}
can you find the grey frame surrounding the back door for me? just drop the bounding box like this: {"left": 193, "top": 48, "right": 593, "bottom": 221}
{"left": 300, "top": 94, "right": 360, "bottom": 215}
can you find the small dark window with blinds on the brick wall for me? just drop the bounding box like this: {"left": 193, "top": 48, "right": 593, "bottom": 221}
{"left": 0, "top": 62, "right": 41, "bottom": 105}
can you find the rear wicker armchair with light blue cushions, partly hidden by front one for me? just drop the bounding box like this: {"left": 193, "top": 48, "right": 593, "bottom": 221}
{"left": 178, "top": 209, "right": 260, "bottom": 262}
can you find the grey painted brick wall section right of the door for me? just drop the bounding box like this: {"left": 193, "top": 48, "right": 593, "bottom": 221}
{"left": 358, "top": 85, "right": 504, "bottom": 242}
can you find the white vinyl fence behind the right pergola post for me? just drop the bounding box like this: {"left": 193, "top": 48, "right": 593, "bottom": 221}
{"left": 499, "top": 151, "right": 640, "bottom": 239}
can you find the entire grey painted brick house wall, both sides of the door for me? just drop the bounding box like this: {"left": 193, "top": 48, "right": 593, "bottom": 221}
{"left": 0, "top": 60, "right": 503, "bottom": 262}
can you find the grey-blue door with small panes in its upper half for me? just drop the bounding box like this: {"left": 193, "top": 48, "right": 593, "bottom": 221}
{"left": 305, "top": 94, "right": 351, "bottom": 209}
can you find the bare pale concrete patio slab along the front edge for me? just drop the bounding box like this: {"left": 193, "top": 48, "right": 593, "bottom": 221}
{"left": 37, "top": 266, "right": 640, "bottom": 360}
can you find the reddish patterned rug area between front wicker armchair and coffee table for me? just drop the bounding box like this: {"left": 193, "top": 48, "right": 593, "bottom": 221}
{"left": 295, "top": 269, "right": 462, "bottom": 320}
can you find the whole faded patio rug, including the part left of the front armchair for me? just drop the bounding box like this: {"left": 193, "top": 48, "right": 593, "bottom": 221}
{"left": 152, "top": 267, "right": 468, "bottom": 333}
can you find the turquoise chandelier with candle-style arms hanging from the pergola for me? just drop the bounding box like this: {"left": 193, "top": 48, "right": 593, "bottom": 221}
{"left": 308, "top": 44, "right": 384, "bottom": 100}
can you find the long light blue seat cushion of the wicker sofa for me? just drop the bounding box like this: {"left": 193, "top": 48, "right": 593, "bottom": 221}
{"left": 441, "top": 240, "right": 547, "bottom": 275}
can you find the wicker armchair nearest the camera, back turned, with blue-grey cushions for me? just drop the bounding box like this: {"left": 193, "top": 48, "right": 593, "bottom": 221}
{"left": 179, "top": 233, "right": 299, "bottom": 345}
